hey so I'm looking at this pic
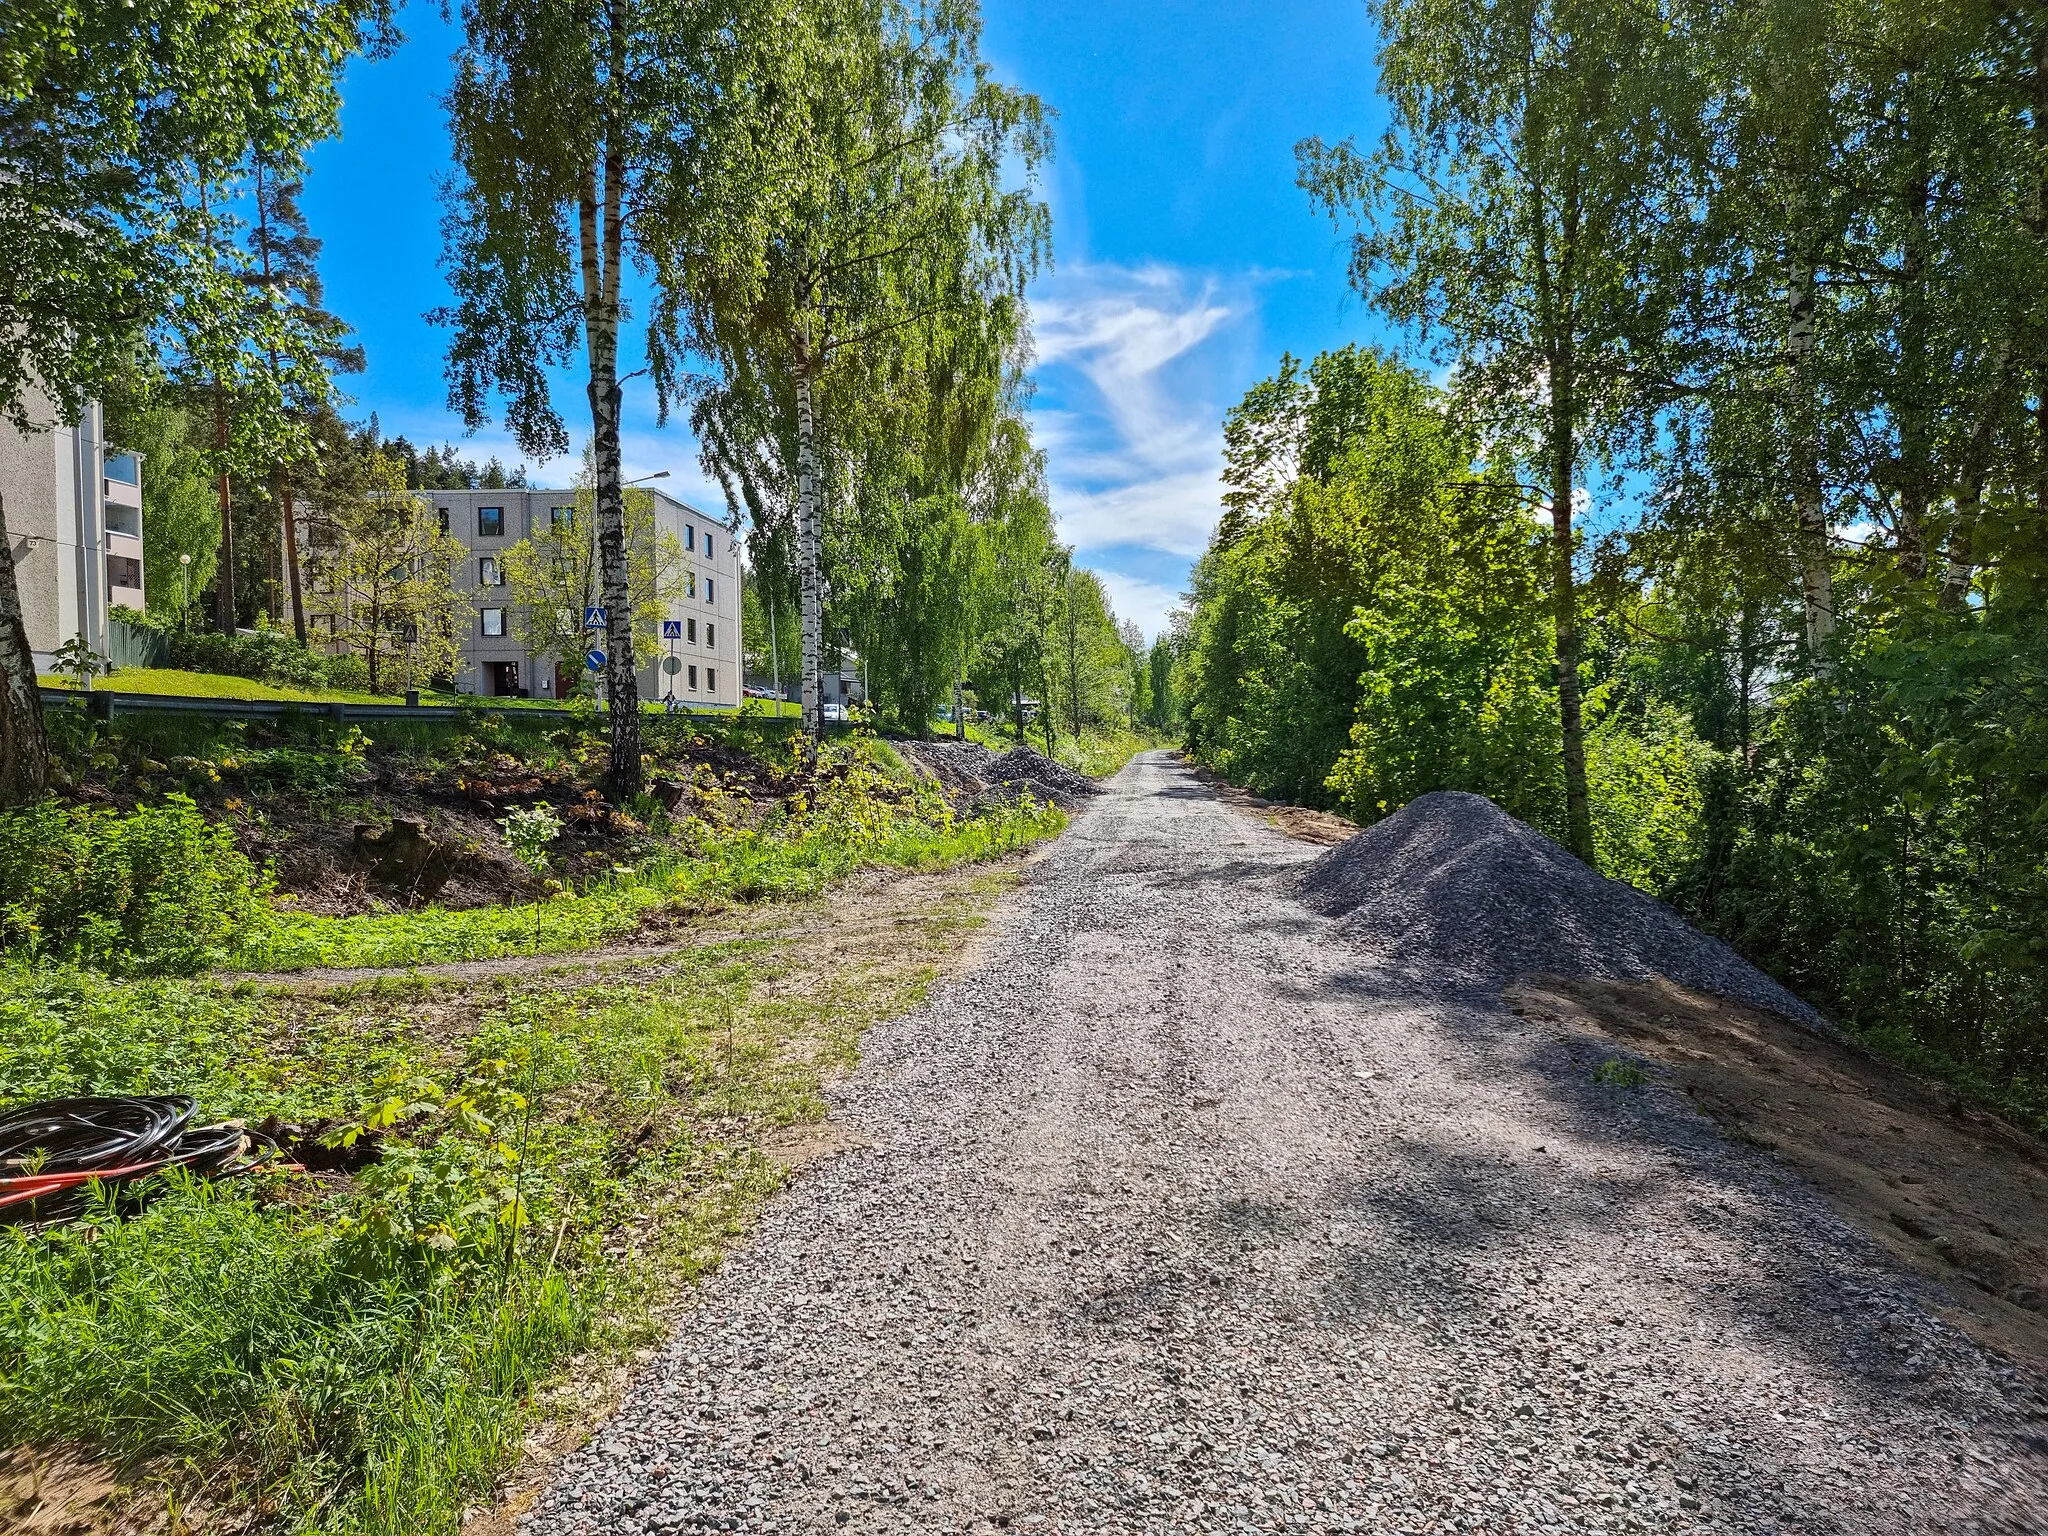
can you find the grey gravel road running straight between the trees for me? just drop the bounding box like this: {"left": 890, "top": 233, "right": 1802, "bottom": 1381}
{"left": 520, "top": 754, "right": 2048, "bottom": 1536}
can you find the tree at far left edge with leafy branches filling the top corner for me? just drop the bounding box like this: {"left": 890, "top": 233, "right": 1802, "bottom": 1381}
{"left": 0, "top": 0, "right": 391, "bottom": 801}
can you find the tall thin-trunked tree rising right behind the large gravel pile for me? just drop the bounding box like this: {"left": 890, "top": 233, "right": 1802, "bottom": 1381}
{"left": 1296, "top": 0, "right": 1698, "bottom": 858}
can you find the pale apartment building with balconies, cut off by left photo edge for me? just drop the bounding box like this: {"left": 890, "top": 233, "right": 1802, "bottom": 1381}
{"left": 0, "top": 395, "right": 143, "bottom": 668}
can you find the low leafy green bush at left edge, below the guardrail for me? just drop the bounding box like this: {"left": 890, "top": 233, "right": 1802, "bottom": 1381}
{"left": 0, "top": 795, "right": 268, "bottom": 973}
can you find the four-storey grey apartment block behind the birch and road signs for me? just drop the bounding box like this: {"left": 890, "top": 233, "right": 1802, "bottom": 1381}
{"left": 422, "top": 485, "right": 741, "bottom": 709}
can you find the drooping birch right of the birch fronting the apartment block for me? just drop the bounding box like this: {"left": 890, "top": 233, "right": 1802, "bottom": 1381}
{"left": 692, "top": 0, "right": 1049, "bottom": 735}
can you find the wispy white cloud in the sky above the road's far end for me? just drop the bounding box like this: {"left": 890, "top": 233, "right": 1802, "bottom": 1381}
{"left": 1032, "top": 264, "right": 1253, "bottom": 581}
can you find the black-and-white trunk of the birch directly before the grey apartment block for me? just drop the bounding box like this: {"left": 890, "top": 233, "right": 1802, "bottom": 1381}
{"left": 578, "top": 135, "right": 643, "bottom": 801}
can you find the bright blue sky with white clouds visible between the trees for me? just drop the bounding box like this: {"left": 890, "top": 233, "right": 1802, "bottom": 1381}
{"left": 305, "top": 0, "right": 1380, "bottom": 633}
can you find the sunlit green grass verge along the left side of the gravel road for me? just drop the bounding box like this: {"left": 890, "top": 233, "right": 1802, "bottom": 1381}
{"left": 0, "top": 754, "right": 1061, "bottom": 1536}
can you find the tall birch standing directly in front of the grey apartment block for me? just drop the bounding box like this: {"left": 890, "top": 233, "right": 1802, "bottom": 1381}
{"left": 434, "top": 0, "right": 788, "bottom": 797}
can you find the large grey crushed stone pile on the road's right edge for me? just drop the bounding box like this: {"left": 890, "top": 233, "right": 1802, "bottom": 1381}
{"left": 1294, "top": 791, "right": 1823, "bottom": 1026}
